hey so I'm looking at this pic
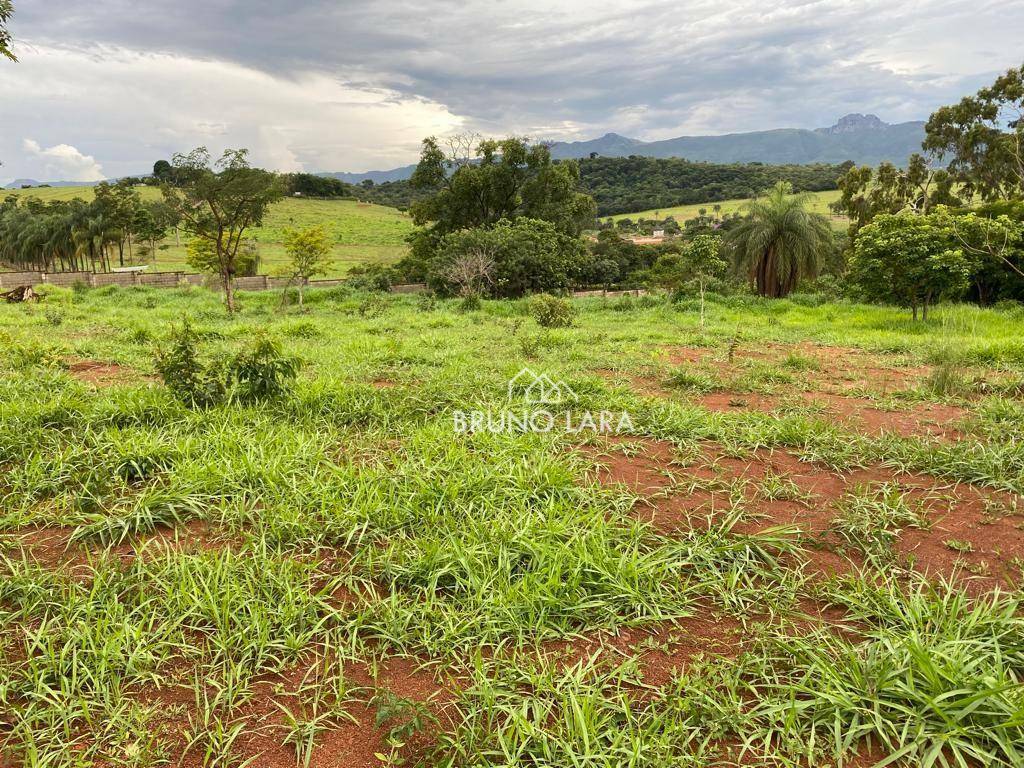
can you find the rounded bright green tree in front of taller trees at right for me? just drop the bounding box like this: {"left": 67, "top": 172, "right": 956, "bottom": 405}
{"left": 850, "top": 211, "right": 975, "bottom": 319}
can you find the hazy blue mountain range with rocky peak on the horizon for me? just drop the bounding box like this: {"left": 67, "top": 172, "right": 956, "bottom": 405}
{"left": 322, "top": 114, "right": 925, "bottom": 184}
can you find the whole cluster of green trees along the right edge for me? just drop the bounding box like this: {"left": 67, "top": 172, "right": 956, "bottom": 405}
{"left": 834, "top": 59, "right": 1024, "bottom": 316}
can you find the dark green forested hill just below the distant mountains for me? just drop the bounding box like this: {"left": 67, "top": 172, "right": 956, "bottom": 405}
{"left": 580, "top": 157, "right": 850, "bottom": 216}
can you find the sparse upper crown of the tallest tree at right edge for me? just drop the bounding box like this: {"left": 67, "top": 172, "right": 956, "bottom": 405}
{"left": 924, "top": 65, "right": 1024, "bottom": 201}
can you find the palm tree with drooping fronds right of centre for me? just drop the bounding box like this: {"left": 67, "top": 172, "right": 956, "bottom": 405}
{"left": 727, "top": 181, "right": 833, "bottom": 299}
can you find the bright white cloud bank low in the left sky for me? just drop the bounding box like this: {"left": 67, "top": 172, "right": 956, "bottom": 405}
{"left": 0, "top": 45, "right": 462, "bottom": 180}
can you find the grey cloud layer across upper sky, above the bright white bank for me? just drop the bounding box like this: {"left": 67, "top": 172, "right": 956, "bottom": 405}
{"left": 2, "top": 0, "right": 1024, "bottom": 180}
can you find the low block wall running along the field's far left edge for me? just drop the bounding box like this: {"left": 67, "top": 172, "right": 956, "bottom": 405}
{"left": 0, "top": 271, "right": 427, "bottom": 293}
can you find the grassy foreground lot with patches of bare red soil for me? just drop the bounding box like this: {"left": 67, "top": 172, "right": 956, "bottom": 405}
{"left": 0, "top": 289, "right": 1024, "bottom": 768}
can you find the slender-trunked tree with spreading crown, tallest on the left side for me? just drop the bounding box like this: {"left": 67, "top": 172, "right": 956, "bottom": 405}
{"left": 161, "top": 146, "right": 284, "bottom": 313}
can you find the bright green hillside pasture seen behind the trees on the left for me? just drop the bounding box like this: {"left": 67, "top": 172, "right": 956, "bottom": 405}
{"left": 4, "top": 186, "right": 413, "bottom": 278}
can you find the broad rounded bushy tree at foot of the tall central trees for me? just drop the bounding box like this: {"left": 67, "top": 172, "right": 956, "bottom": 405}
{"left": 428, "top": 218, "right": 586, "bottom": 298}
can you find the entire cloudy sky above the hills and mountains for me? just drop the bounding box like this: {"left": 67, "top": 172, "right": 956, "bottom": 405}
{"left": 0, "top": 0, "right": 1024, "bottom": 182}
